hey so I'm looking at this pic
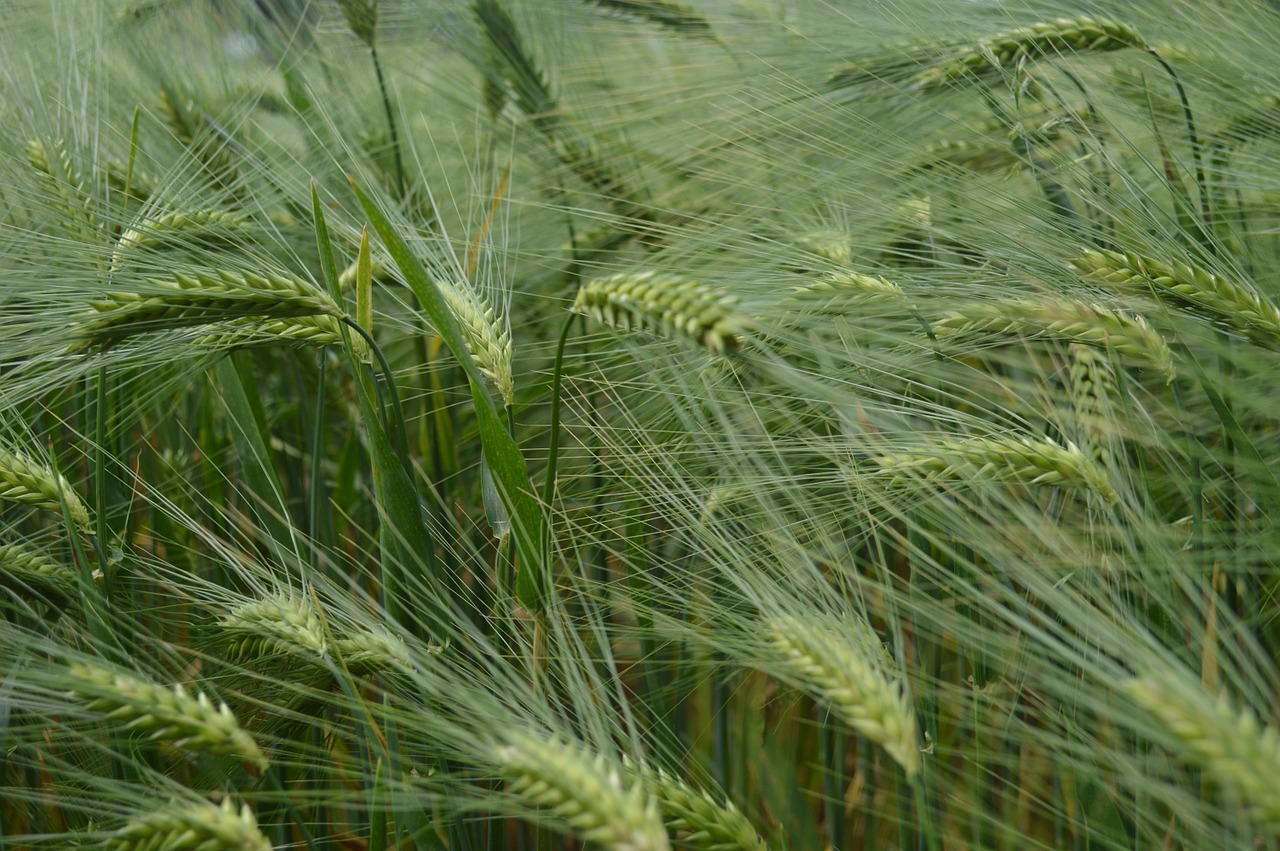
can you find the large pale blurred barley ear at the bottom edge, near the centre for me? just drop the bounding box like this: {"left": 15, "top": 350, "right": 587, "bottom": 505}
{"left": 492, "top": 732, "right": 669, "bottom": 851}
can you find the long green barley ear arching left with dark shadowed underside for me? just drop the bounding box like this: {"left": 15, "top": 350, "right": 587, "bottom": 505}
{"left": 78, "top": 270, "right": 342, "bottom": 346}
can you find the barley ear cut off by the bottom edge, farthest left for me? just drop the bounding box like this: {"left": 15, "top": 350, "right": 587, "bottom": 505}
{"left": 108, "top": 797, "right": 271, "bottom": 851}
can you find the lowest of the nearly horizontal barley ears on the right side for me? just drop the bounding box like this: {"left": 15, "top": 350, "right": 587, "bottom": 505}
{"left": 874, "top": 436, "right": 1120, "bottom": 504}
